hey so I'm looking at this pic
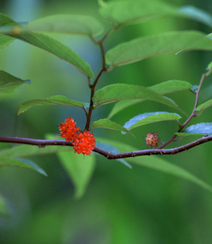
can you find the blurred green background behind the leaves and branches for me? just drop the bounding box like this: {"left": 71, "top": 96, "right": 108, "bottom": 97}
{"left": 0, "top": 0, "right": 212, "bottom": 244}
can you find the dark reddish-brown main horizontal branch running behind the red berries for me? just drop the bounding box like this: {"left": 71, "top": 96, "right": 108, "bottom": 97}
{"left": 0, "top": 135, "right": 212, "bottom": 159}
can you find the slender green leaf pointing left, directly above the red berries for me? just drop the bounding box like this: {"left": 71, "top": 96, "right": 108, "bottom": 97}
{"left": 18, "top": 95, "right": 85, "bottom": 115}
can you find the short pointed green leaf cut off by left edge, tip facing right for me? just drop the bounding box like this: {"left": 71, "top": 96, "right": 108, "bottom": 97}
{"left": 0, "top": 70, "right": 26, "bottom": 93}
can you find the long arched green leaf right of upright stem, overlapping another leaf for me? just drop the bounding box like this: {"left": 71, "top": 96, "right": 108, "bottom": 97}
{"left": 93, "top": 84, "right": 178, "bottom": 109}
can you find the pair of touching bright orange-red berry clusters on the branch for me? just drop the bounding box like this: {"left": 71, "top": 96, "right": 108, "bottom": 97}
{"left": 59, "top": 118, "right": 96, "bottom": 155}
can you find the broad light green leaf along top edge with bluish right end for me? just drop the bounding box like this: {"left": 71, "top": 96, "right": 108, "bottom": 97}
{"left": 99, "top": 0, "right": 212, "bottom": 27}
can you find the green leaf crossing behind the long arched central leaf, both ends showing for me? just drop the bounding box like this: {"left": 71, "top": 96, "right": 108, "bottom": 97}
{"left": 108, "top": 80, "right": 192, "bottom": 119}
